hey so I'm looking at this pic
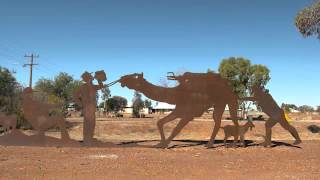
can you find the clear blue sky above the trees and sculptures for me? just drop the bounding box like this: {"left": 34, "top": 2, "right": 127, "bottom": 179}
{"left": 0, "top": 0, "right": 320, "bottom": 106}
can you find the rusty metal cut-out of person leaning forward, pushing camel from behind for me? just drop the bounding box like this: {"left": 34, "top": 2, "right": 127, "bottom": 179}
{"left": 242, "top": 85, "right": 301, "bottom": 146}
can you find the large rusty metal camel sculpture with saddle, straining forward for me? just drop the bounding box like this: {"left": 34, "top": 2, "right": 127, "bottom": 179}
{"left": 119, "top": 72, "right": 239, "bottom": 148}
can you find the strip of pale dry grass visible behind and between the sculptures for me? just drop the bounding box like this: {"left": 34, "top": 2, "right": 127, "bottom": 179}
{"left": 42, "top": 118, "right": 320, "bottom": 141}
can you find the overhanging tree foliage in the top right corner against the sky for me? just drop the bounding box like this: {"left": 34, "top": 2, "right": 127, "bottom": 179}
{"left": 295, "top": 1, "right": 320, "bottom": 39}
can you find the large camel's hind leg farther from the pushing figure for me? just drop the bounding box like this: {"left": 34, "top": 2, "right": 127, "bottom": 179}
{"left": 207, "top": 104, "right": 226, "bottom": 148}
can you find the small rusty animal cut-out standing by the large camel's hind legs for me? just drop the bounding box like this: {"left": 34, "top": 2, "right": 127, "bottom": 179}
{"left": 221, "top": 121, "right": 255, "bottom": 147}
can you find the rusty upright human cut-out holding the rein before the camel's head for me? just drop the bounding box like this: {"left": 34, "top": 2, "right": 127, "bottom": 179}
{"left": 75, "top": 72, "right": 104, "bottom": 145}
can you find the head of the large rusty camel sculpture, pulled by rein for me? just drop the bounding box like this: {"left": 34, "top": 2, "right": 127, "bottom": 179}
{"left": 119, "top": 73, "right": 145, "bottom": 90}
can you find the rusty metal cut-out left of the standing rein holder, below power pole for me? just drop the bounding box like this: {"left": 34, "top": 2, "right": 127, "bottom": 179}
{"left": 21, "top": 87, "right": 70, "bottom": 143}
